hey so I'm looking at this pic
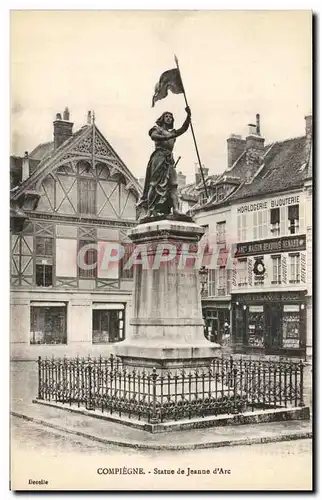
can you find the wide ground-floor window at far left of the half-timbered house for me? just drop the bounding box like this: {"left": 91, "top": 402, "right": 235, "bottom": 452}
{"left": 30, "top": 302, "right": 67, "bottom": 344}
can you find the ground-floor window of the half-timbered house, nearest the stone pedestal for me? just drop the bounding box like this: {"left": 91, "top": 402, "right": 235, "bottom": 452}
{"left": 92, "top": 304, "right": 125, "bottom": 344}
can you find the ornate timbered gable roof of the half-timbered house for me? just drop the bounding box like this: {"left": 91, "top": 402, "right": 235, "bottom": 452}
{"left": 11, "top": 124, "right": 142, "bottom": 200}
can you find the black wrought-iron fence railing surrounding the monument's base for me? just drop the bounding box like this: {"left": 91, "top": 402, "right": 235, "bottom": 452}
{"left": 38, "top": 356, "right": 304, "bottom": 423}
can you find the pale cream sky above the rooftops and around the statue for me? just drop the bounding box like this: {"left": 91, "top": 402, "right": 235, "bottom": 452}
{"left": 10, "top": 10, "right": 312, "bottom": 182}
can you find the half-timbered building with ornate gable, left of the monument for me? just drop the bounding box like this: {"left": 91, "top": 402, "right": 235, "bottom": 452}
{"left": 10, "top": 108, "right": 142, "bottom": 359}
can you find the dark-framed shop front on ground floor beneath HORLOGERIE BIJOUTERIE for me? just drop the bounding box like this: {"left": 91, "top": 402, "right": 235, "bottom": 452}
{"left": 232, "top": 291, "right": 306, "bottom": 358}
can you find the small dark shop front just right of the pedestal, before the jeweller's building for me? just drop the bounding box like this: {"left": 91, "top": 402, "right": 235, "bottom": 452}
{"left": 202, "top": 302, "right": 231, "bottom": 344}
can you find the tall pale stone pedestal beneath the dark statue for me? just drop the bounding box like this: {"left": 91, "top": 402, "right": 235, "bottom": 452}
{"left": 114, "top": 216, "right": 220, "bottom": 368}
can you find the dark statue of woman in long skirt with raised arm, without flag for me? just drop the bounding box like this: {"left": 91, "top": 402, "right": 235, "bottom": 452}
{"left": 138, "top": 107, "right": 191, "bottom": 217}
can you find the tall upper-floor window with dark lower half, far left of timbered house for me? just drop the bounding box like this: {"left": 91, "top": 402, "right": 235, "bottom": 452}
{"left": 36, "top": 237, "right": 54, "bottom": 287}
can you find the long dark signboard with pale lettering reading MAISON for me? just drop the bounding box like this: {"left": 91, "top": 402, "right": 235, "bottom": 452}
{"left": 236, "top": 235, "right": 306, "bottom": 257}
